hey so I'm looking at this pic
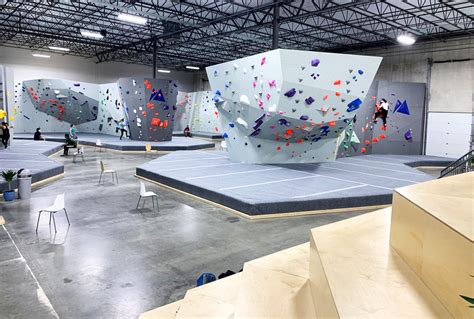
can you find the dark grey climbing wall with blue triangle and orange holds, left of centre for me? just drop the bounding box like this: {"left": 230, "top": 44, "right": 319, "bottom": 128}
{"left": 118, "top": 78, "right": 178, "bottom": 142}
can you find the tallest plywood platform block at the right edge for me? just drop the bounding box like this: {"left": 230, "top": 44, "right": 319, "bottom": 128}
{"left": 390, "top": 172, "right": 474, "bottom": 318}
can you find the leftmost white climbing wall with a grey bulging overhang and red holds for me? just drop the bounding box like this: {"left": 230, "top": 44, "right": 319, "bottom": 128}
{"left": 13, "top": 79, "right": 124, "bottom": 134}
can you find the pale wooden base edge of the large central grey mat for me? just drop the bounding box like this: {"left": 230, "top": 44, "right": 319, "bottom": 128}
{"left": 134, "top": 174, "right": 391, "bottom": 220}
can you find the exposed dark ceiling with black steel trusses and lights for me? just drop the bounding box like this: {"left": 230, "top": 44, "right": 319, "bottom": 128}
{"left": 0, "top": 0, "right": 474, "bottom": 70}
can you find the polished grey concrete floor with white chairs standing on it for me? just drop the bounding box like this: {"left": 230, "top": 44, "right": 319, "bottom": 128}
{"left": 0, "top": 148, "right": 374, "bottom": 318}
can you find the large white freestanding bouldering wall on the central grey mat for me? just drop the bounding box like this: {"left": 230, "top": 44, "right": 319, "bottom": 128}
{"left": 206, "top": 49, "right": 382, "bottom": 163}
